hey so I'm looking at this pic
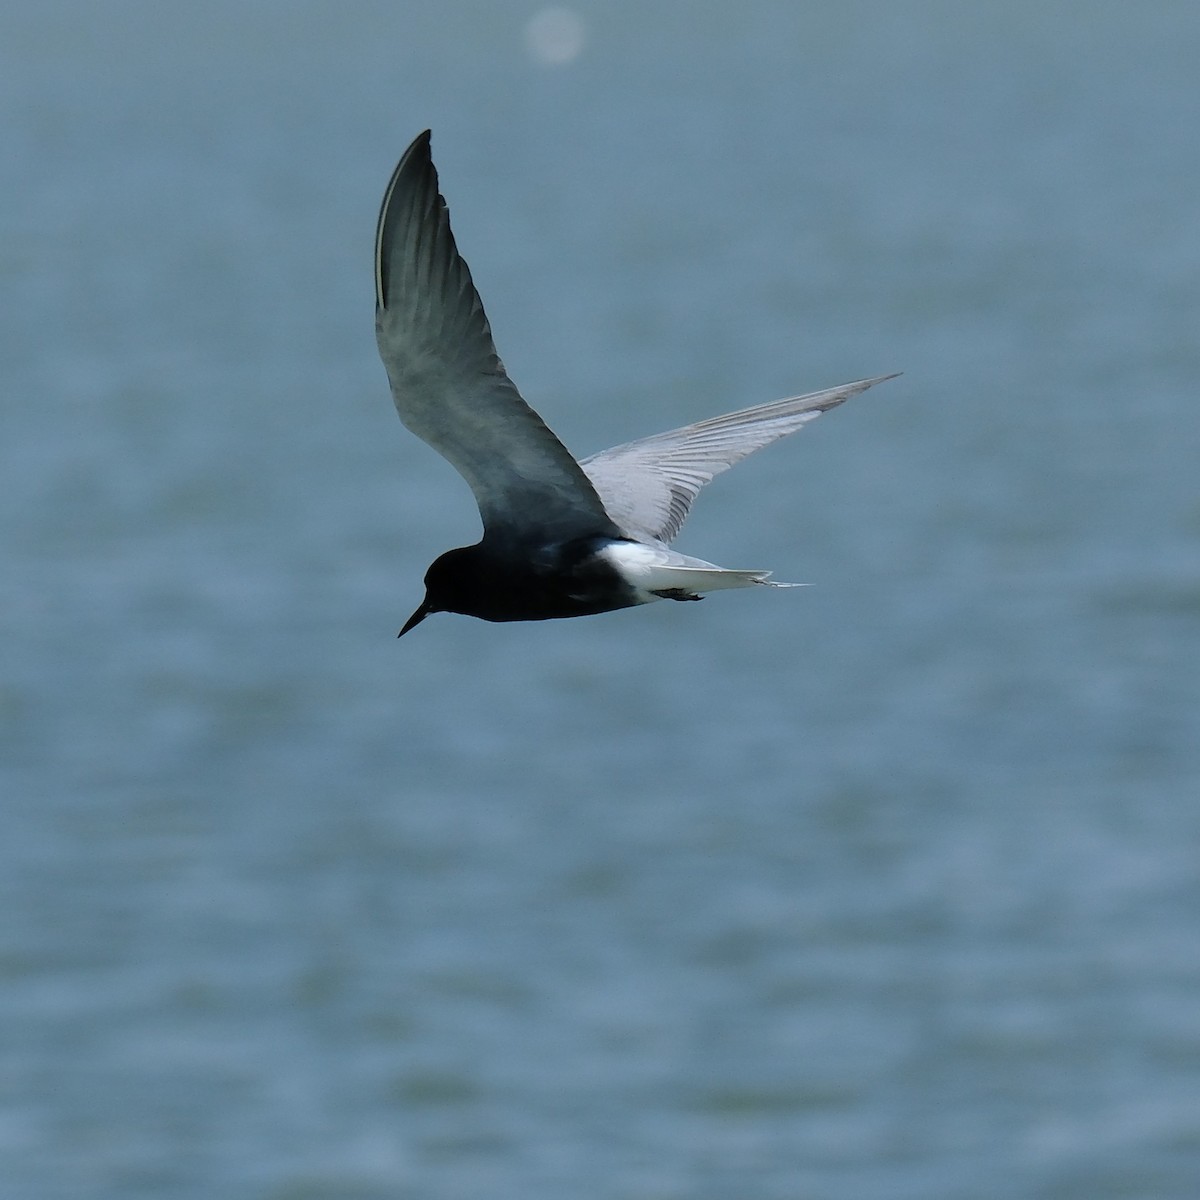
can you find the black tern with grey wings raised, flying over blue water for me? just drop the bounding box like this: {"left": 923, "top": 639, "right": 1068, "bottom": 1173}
{"left": 376, "top": 130, "right": 894, "bottom": 637}
